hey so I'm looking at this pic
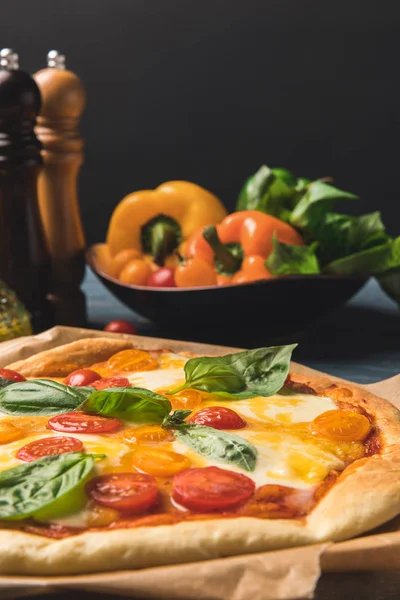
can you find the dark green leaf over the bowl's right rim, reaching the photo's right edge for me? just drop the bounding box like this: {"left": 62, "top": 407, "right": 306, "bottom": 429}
{"left": 324, "top": 237, "right": 400, "bottom": 275}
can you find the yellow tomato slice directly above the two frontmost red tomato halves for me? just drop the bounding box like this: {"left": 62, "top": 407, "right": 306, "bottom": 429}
{"left": 132, "top": 448, "right": 191, "bottom": 477}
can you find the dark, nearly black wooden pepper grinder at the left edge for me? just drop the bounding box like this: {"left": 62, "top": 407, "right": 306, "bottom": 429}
{"left": 0, "top": 48, "right": 50, "bottom": 331}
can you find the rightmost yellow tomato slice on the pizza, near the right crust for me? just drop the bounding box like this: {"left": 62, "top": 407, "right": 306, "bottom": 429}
{"left": 311, "top": 410, "right": 371, "bottom": 442}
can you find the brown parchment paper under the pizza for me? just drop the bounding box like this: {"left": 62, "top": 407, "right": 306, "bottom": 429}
{"left": 0, "top": 327, "right": 400, "bottom": 600}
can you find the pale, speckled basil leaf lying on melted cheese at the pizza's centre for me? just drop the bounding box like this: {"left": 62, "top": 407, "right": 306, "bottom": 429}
{"left": 174, "top": 424, "right": 257, "bottom": 471}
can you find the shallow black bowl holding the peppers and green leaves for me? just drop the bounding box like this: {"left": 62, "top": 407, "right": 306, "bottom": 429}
{"left": 86, "top": 244, "right": 366, "bottom": 343}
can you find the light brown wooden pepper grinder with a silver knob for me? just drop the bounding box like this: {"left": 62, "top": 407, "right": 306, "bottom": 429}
{"left": 34, "top": 50, "right": 86, "bottom": 326}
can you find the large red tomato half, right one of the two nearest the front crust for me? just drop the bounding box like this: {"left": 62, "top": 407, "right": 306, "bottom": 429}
{"left": 172, "top": 467, "right": 256, "bottom": 512}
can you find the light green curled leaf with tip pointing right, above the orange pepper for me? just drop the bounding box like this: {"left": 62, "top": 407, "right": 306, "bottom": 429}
{"left": 290, "top": 181, "right": 358, "bottom": 229}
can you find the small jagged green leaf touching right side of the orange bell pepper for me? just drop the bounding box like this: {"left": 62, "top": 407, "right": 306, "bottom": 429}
{"left": 266, "top": 234, "right": 320, "bottom": 275}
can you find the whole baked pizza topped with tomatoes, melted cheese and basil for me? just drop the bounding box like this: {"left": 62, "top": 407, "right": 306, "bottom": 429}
{"left": 0, "top": 338, "right": 400, "bottom": 575}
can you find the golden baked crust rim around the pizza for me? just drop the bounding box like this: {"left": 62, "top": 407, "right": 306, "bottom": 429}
{"left": 0, "top": 339, "right": 400, "bottom": 575}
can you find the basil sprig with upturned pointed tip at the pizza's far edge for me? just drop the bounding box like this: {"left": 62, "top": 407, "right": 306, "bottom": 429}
{"left": 169, "top": 344, "right": 297, "bottom": 399}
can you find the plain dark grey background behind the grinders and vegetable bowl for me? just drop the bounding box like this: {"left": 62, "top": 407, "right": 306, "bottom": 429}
{"left": 0, "top": 0, "right": 400, "bottom": 242}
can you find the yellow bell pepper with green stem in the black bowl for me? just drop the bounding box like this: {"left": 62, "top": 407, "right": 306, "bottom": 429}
{"left": 107, "top": 181, "right": 226, "bottom": 265}
